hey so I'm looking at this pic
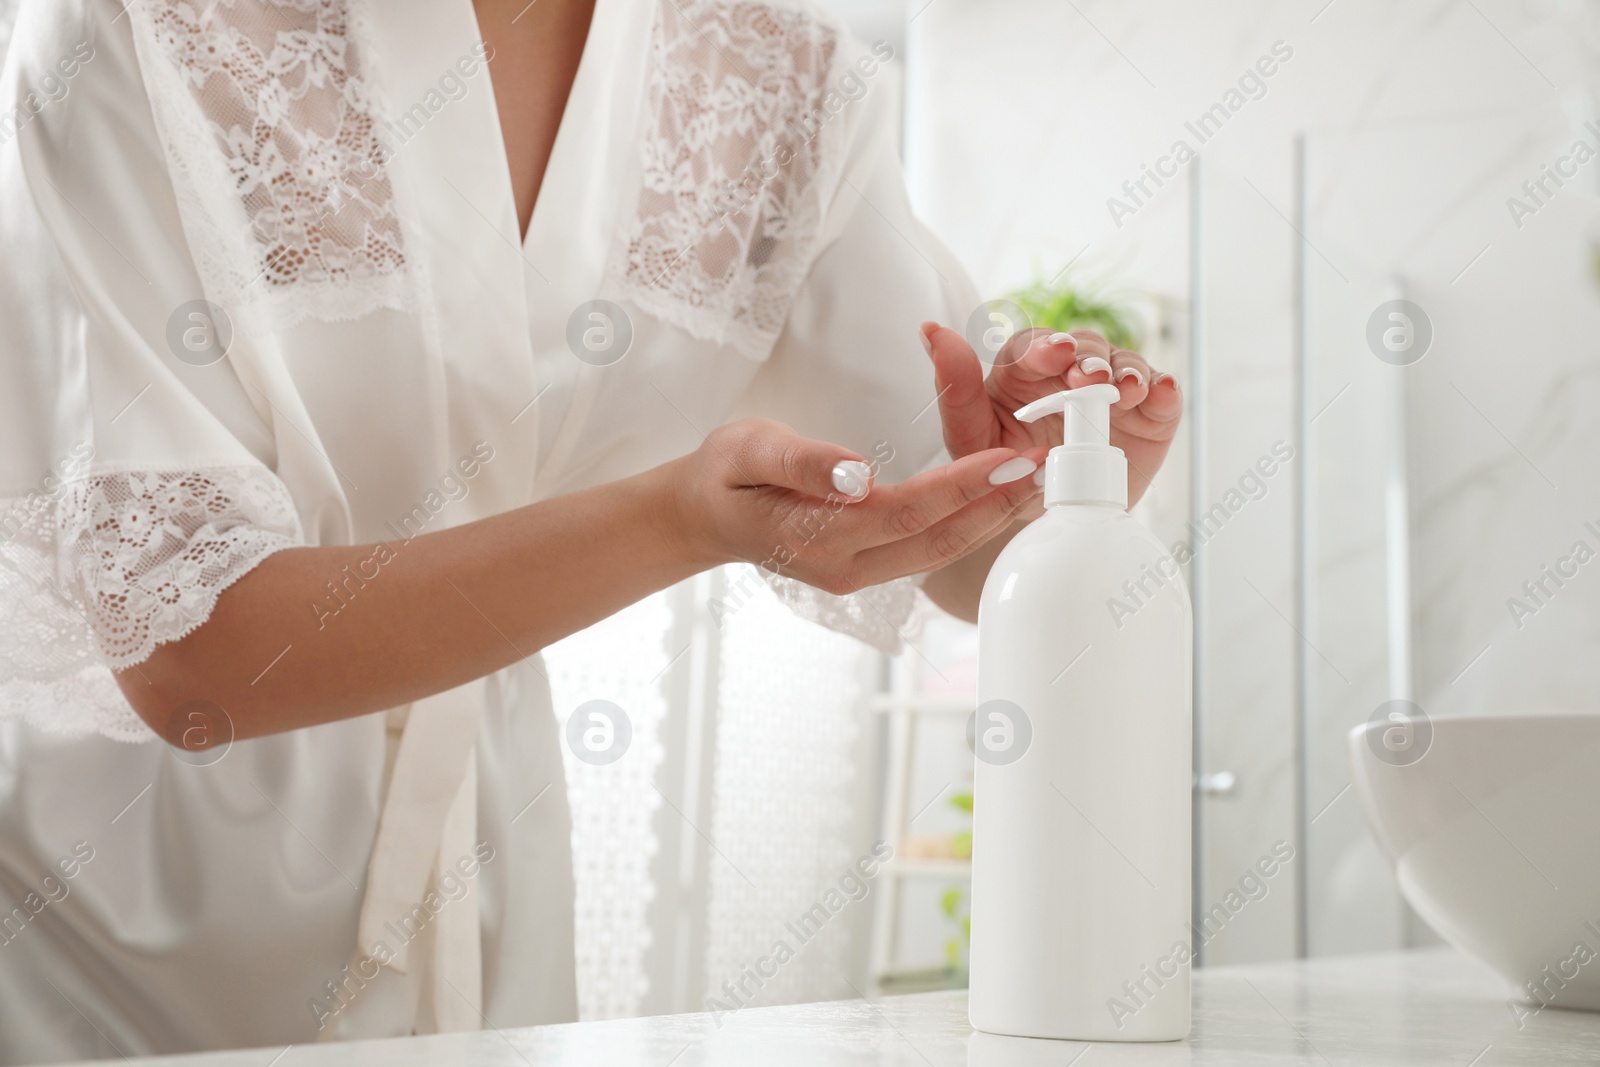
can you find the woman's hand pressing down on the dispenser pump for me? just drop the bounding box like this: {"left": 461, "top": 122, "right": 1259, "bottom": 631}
{"left": 922, "top": 322, "right": 1182, "bottom": 504}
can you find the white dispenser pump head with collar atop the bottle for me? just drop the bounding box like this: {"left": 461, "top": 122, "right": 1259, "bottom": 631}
{"left": 1016, "top": 382, "right": 1128, "bottom": 507}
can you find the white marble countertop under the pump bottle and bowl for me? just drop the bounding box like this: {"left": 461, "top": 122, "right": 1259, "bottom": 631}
{"left": 53, "top": 949, "right": 1600, "bottom": 1067}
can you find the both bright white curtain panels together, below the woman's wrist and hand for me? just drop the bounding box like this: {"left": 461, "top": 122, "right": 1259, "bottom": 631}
{"left": 546, "top": 566, "right": 882, "bottom": 1021}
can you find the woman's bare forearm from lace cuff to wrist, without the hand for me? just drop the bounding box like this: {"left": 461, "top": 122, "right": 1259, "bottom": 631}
{"left": 117, "top": 464, "right": 704, "bottom": 744}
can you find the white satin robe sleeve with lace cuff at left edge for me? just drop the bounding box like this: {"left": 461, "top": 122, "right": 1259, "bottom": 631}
{"left": 0, "top": 0, "right": 304, "bottom": 741}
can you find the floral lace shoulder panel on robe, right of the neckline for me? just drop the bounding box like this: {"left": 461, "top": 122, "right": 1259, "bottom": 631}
{"left": 608, "top": 0, "right": 848, "bottom": 358}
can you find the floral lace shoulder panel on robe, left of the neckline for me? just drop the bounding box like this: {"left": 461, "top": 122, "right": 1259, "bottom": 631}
{"left": 128, "top": 0, "right": 416, "bottom": 330}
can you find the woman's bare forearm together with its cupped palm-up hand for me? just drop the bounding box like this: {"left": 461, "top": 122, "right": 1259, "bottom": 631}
{"left": 117, "top": 419, "right": 1037, "bottom": 744}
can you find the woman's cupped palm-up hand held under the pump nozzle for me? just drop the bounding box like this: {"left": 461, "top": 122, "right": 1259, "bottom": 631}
{"left": 670, "top": 419, "right": 1045, "bottom": 593}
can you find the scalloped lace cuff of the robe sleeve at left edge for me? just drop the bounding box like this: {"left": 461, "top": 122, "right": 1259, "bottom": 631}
{"left": 0, "top": 467, "right": 304, "bottom": 741}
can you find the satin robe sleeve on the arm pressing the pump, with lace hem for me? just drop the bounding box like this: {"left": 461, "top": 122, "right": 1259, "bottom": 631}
{"left": 739, "top": 42, "right": 979, "bottom": 654}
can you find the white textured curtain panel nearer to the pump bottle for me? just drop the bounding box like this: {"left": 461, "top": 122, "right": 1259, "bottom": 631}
{"left": 704, "top": 572, "right": 880, "bottom": 1005}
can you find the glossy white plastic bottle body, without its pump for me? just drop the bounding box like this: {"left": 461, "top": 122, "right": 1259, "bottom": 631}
{"left": 970, "top": 504, "right": 1194, "bottom": 1041}
